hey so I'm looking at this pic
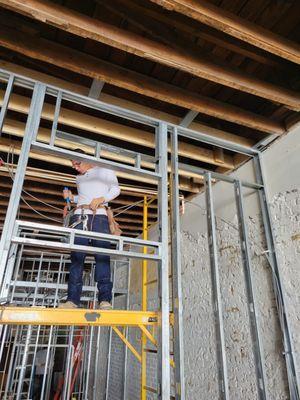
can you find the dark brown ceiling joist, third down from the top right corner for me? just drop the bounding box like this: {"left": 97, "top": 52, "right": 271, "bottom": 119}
{"left": 0, "top": 26, "right": 286, "bottom": 135}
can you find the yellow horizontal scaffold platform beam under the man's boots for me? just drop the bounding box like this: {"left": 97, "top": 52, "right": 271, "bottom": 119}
{"left": 0, "top": 307, "right": 158, "bottom": 326}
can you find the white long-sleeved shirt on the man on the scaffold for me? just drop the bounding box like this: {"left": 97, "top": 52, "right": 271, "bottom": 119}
{"left": 74, "top": 167, "right": 120, "bottom": 215}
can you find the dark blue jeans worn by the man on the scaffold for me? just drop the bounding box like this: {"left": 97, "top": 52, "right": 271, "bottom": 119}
{"left": 67, "top": 215, "right": 112, "bottom": 305}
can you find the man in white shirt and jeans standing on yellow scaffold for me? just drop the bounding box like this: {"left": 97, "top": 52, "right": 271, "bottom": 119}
{"left": 59, "top": 149, "right": 120, "bottom": 310}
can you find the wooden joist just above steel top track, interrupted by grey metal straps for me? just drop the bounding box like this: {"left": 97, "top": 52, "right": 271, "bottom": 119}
{"left": 0, "top": 60, "right": 254, "bottom": 147}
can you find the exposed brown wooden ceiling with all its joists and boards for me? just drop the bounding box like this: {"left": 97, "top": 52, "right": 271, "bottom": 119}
{"left": 0, "top": 0, "right": 300, "bottom": 236}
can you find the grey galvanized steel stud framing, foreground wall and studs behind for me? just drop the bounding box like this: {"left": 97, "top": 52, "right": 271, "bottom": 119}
{"left": 0, "top": 70, "right": 299, "bottom": 400}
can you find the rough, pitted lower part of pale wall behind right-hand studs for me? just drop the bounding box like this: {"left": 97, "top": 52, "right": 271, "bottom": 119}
{"left": 182, "top": 190, "right": 300, "bottom": 400}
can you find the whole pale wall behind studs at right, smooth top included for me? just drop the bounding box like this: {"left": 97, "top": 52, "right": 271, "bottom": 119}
{"left": 106, "top": 127, "right": 300, "bottom": 400}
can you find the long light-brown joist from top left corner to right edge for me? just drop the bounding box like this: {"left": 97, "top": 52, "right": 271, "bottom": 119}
{"left": 0, "top": 0, "right": 300, "bottom": 111}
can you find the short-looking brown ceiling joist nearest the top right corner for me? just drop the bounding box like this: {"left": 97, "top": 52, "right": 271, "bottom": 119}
{"left": 151, "top": 0, "right": 300, "bottom": 64}
